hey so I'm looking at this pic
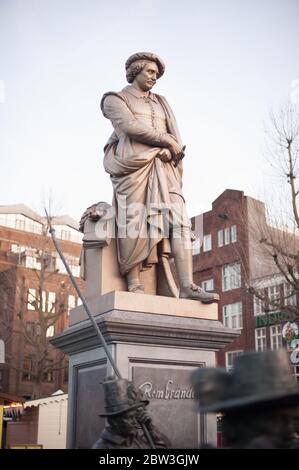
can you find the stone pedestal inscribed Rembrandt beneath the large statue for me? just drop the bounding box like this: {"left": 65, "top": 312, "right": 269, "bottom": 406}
{"left": 51, "top": 291, "right": 238, "bottom": 448}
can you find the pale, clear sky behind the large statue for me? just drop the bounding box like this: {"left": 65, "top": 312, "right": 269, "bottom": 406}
{"left": 0, "top": 0, "right": 299, "bottom": 219}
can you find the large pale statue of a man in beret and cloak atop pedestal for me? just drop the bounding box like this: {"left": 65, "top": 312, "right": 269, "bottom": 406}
{"left": 101, "top": 52, "right": 219, "bottom": 303}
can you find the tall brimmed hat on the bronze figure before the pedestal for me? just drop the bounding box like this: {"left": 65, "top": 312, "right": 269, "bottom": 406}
{"left": 100, "top": 376, "right": 146, "bottom": 416}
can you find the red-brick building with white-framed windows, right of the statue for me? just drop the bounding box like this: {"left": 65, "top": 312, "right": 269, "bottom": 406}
{"left": 192, "top": 189, "right": 299, "bottom": 377}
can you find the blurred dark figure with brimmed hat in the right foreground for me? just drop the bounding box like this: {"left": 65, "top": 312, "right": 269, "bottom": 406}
{"left": 192, "top": 349, "right": 299, "bottom": 449}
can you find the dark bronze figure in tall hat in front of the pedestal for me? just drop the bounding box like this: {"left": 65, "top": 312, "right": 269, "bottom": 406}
{"left": 92, "top": 377, "right": 171, "bottom": 449}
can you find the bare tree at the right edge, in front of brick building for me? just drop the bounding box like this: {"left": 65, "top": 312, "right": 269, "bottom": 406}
{"left": 239, "top": 104, "right": 299, "bottom": 314}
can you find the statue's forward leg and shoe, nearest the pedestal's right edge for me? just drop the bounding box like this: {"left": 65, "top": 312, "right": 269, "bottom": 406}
{"left": 171, "top": 229, "right": 219, "bottom": 304}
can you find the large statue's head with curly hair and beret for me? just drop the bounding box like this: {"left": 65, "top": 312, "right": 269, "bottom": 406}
{"left": 126, "top": 52, "right": 165, "bottom": 91}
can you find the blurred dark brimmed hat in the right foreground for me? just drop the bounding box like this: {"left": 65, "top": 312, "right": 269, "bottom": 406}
{"left": 192, "top": 349, "right": 299, "bottom": 411}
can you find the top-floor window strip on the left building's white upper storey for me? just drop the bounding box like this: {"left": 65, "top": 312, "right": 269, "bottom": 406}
{"left": 0, "top": 214, "right": 83, "bottom": 243}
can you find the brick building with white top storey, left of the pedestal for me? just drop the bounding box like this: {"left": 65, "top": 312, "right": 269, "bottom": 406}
{"left": 0, "top": 204, "right": 82, "bottom": 399}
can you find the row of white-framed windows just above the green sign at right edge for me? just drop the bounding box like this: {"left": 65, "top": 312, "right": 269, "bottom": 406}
{"left": 253, "top": 284, "right": 297, "bottom": 315}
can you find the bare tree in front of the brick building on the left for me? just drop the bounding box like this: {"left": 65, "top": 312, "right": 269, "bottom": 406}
{"left": 0, "top": 215, "right": 69, "bottom": 399}
